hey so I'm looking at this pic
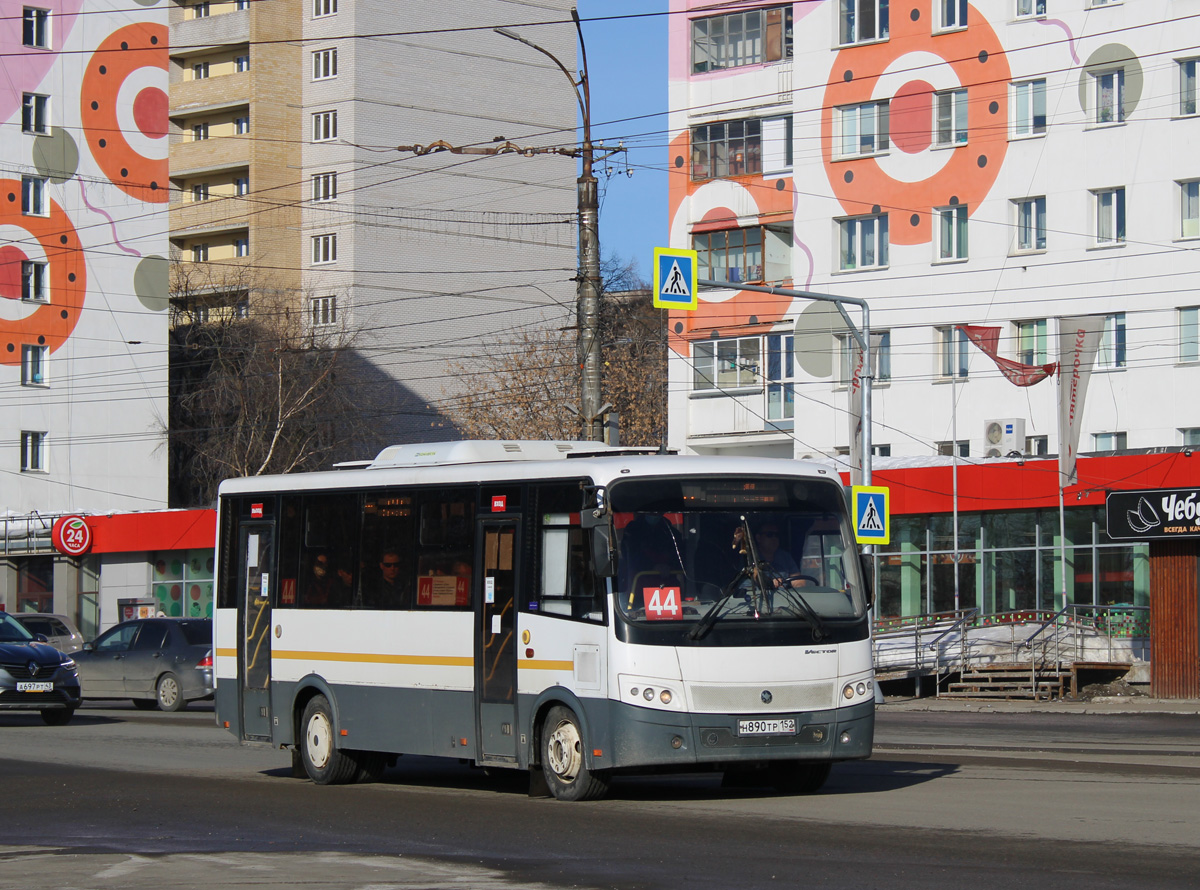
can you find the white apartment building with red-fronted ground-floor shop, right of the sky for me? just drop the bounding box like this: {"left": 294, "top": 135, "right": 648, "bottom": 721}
{"left": 667, "top": 0, "right": 1200, "bottom": 647}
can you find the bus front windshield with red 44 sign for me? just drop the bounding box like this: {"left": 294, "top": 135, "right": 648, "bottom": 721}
{"left": 610, "top": 479, "right": 866, "bottom": 639}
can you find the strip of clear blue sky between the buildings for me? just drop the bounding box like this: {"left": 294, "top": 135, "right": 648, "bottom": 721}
{"left": 577, "top": 0, "right": 667, "bottom": 279}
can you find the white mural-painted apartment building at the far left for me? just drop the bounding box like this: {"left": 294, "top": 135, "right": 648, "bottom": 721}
{"left": 0, "top": 0, "right": 168, "bottom": 614}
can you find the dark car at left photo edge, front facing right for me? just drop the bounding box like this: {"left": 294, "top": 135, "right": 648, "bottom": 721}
{"left": 0, "top": 612, "right": 79, "bottom": 726}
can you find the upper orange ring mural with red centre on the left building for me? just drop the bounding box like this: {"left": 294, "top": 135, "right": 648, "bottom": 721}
{"left": 80, "top": 23, "right": 169, "bottom": 204}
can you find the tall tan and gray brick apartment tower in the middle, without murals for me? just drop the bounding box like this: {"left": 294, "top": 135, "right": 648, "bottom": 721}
{"left": 170, "top": 0, "right": 576, "bottom": 443}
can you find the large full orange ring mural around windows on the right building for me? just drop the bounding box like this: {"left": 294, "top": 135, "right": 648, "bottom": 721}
{"left": 821, "top": 0, "right": 1012, "bottom": 245}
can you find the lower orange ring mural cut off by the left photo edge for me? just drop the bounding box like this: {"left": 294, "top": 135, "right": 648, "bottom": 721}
{"left": 0, "top": 179, "right": 88, "bottom": 365}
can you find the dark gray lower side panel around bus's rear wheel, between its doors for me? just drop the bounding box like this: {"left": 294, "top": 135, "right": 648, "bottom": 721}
{"left": 271, "top": 681, "right": 475, "bottom": 759}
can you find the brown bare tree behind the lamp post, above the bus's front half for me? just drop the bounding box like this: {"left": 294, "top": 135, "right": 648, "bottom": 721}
{"left": 445, "top": 257, "right": 666, "bottom": 446}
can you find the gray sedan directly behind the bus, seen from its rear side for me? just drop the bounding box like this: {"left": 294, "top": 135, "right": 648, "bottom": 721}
{"left": 74, "top": 618, "right": 212, "bottom": 711}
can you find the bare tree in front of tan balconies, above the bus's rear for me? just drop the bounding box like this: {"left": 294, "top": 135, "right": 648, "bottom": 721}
{"left": 168, "top": 264, "right": 373, "bottom": 506}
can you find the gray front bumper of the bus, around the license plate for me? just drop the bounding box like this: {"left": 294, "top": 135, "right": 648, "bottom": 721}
{"left": 610, "top": 702, "right": 875, "bottom": 769}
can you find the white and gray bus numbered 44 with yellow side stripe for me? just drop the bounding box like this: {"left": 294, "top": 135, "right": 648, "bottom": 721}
{"left": 215, "top": 441, "right": 875, "bottom": 800}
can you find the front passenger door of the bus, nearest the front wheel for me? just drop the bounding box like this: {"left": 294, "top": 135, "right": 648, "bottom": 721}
{"left": 475, "top": 519, "right": 520, "bottom": 763}
